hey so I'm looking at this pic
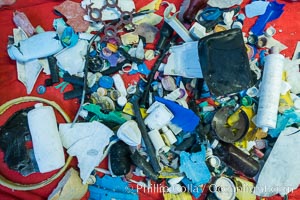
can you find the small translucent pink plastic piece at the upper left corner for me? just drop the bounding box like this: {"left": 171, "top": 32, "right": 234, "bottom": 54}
{"left": 13, "top": 11, "right": 35, "bottom": 37}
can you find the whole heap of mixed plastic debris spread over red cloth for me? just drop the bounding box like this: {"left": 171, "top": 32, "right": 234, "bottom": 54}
{"left": 0, "top": 0, "right": 300, "bottom": 200}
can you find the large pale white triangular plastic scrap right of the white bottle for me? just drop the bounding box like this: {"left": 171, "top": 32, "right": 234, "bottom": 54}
{"left": 59, "top": 121, "right": 114, "bottom": 184}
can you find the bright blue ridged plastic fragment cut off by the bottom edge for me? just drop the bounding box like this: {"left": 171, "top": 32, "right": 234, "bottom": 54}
{"left": 89, "top": 175, "right": 139, "bottom": 200}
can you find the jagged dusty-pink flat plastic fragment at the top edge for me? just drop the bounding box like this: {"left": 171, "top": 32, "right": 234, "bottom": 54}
{"left": 54, "top": 1, "right": 90, "bottom": 32}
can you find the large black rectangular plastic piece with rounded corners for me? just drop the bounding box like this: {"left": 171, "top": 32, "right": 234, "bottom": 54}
{"left": 198, "top": 29, "right": 254, "bottom": 96}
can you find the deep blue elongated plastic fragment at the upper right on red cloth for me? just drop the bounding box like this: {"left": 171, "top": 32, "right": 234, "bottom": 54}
{"left": 251, "top": 1, "right": 285, "bottom": 36}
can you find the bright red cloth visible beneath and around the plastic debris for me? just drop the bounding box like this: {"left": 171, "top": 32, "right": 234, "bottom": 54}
{"left": 0, "top": 0, "right": 300, "bottom": 200}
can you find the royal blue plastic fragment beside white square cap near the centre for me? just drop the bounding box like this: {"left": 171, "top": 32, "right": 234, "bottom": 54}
{"left": 155, "top": 96, "right": 200, "bottom": 132}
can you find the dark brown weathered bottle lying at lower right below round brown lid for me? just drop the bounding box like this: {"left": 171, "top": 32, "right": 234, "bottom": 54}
{"left": 213, "top": 141, "right": 260, "bottom": 177}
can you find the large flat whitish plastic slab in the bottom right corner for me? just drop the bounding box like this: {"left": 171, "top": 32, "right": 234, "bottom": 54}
{"left": 254, "top": 127, "right": 300, "bottom": 197}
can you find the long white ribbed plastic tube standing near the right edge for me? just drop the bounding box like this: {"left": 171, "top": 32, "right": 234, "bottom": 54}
{"left": 255, "top": 48, "right": 284, "bottom": 132}
